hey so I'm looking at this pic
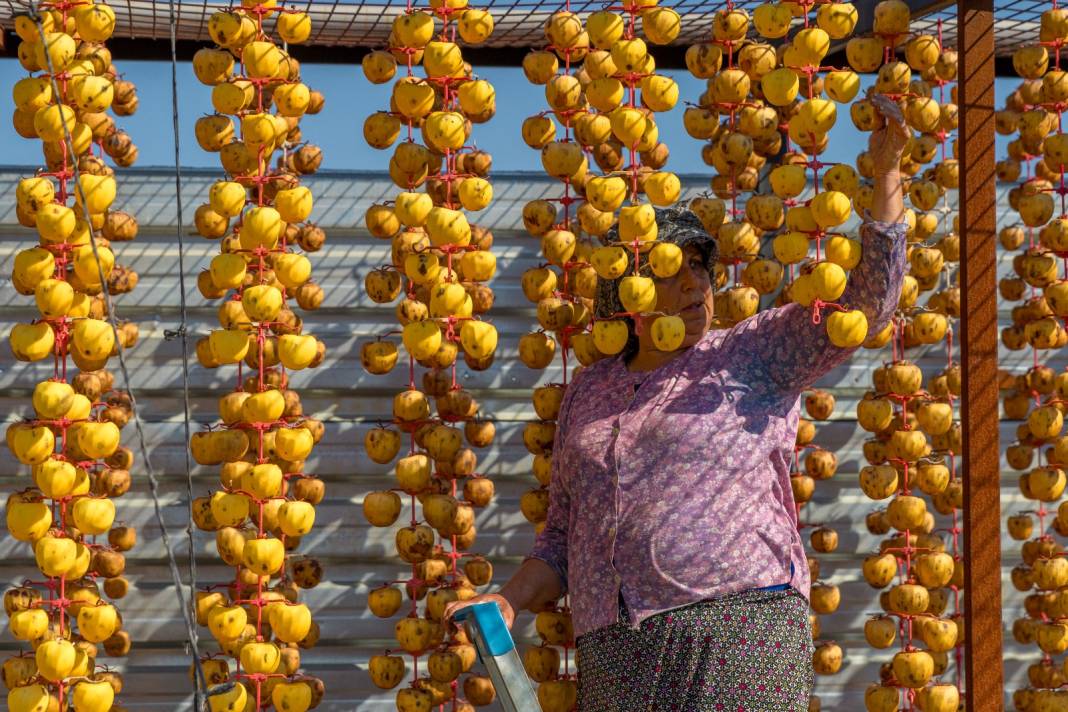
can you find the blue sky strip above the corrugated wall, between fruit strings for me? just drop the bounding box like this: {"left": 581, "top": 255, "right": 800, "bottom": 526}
{"left": 0, "top": 58, "right": 1009, "bottom": 175}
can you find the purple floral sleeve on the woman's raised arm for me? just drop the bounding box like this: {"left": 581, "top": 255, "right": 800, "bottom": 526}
{"left": 725, "top": 221, "right": 907, "bottom": 393}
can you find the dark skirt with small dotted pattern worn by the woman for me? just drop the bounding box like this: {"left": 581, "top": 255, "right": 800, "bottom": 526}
{"left": 577, "top": 588, "right": 813, "bottom": 712}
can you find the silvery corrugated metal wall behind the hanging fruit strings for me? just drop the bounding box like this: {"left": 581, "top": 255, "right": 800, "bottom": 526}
{"left": 0, "top": 168, "right": 1037, "bottom": 712}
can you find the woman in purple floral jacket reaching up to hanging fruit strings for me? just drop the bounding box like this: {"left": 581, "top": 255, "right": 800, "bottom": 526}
{"left": 446, "top": 101, "right": 909, "bottom": 712}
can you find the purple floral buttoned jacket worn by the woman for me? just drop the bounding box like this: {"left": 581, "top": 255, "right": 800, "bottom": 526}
{"left": 530, "top": 222, "right": 906, "bottom": 635}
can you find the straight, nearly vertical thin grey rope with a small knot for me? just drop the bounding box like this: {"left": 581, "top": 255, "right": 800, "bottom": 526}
{"left": 168, "top": 0, "right": 200, "bottom": 709}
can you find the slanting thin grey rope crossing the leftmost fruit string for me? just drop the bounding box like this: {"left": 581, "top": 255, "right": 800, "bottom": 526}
{"left": 29, "top": 9, "right": 207, "bottom": 710}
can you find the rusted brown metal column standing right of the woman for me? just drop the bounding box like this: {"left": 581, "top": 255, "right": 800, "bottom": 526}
{"left": 957, "top": 0, "right": 1004, "bottom": 712}
